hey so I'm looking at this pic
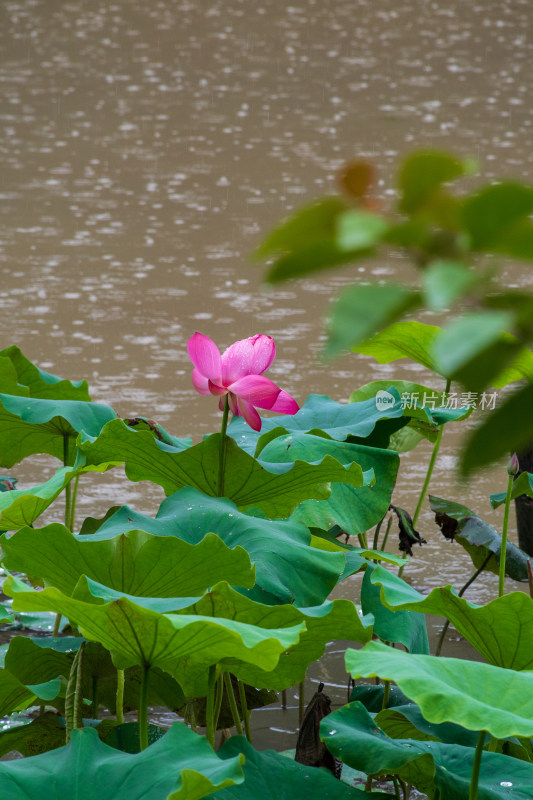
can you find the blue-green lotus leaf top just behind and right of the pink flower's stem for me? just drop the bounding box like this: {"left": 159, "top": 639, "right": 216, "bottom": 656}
{"left": 228, "top": 394, "right": 403, "bottom": 455}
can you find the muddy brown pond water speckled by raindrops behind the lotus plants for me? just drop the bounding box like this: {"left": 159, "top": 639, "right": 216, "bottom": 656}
{"left": 0, "top": 0, "right": 533, "bottom": 752}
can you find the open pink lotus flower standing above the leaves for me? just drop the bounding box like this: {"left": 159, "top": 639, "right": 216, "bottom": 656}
{"left": 187, "top": 333, "right": 298, "bottom": 431}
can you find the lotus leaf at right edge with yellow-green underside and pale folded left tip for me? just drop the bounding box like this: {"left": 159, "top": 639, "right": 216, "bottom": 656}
{"left": 371, "top": 566, "right": 533, "bottom": 670}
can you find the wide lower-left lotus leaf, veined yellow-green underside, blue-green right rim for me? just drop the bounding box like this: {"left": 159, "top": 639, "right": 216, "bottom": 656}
{"left": 4, "top": 577, "right": 304, "bottom": 697}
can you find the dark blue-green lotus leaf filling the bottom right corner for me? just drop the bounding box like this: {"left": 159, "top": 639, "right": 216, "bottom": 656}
{"left": 320, "top": 700, "right": 533, "bottom": 800}
